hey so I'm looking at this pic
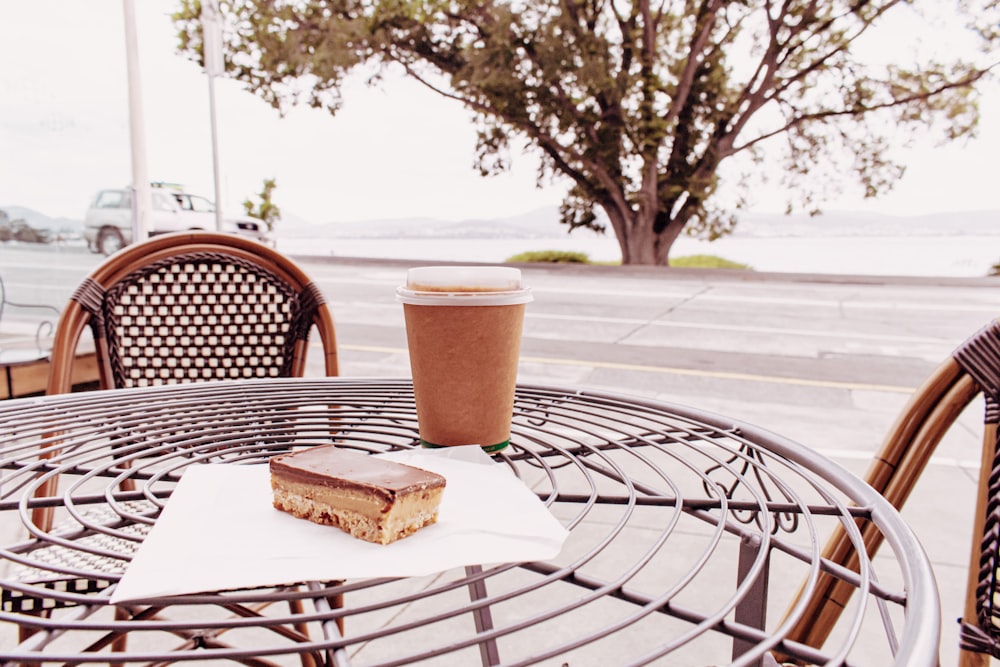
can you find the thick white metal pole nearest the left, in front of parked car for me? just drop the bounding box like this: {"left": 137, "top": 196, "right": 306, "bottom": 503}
{"left": 124, "top": 0, "right": 153, "bottom": 243}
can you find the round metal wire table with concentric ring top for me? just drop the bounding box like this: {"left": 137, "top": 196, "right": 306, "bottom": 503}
{"left": 0, "top": 378, "right": 940, "bottom": 666}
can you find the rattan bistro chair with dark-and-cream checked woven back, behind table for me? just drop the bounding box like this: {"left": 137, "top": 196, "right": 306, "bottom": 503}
{"left": 3, "top": 231, "right": 338, "bottom": 664}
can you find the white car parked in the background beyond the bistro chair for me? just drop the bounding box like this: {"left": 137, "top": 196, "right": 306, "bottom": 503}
{"left": 83, "top": 187, "right": 274, "bottom": 255}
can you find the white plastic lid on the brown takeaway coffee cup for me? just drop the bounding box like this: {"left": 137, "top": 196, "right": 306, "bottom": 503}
{"left": 396, "top": 266, "right": 533, "bottom": 306}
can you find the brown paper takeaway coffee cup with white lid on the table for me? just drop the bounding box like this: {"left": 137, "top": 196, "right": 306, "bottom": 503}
{"left": 396, "top": 266, "right": 532, "bottom": 452}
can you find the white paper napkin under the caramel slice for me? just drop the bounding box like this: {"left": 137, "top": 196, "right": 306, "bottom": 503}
{"left": 111, "top": 446, "right": 569, "bottom": 603}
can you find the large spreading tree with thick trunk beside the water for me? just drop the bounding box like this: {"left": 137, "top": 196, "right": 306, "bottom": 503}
{"left": 175, "top": 0, "right": 1000, "bottom": 264}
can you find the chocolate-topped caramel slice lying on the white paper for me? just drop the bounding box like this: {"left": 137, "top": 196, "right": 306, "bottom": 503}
{"left": 270, "top": 445, "right": 445, "bottom": 544}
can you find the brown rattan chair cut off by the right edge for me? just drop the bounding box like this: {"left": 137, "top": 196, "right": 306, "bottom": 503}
{"left": 789, "top": 320, "right": 1000, "bottom": 667}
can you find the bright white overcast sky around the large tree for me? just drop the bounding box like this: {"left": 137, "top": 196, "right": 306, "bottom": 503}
{"left": 0, "top": 0, "right": 1000, "bottom": 223}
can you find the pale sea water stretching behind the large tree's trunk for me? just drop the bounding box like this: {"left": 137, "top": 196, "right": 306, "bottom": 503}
{"left": 278, "top": 215, "right": 1000, "bottom": 277}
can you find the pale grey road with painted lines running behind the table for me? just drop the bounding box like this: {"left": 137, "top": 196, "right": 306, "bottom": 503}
{"left": 0, "top": 245, "right": 1000, "bottom": 460}
